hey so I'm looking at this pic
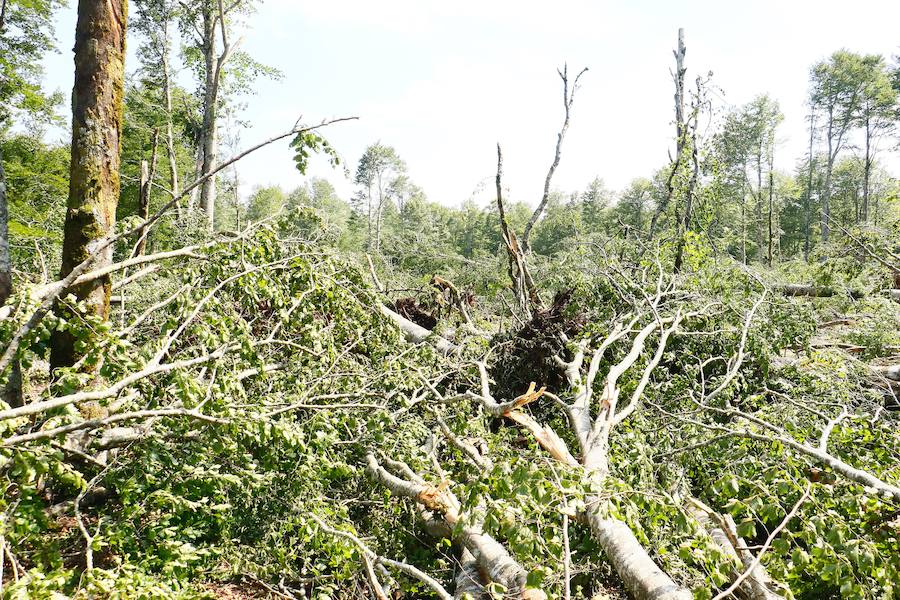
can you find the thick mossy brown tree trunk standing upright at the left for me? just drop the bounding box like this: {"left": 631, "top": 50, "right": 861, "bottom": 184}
{"left": 50, "top": 0, "right": 128, "bottom": 369}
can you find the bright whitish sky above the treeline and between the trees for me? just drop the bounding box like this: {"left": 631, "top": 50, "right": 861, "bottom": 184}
{"left": 38, "top": 0, "right": 900, "bottom": 206}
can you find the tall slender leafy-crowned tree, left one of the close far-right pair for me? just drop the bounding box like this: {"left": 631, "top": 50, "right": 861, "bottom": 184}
{"left": 810, "top": 50, "right": 869, "bottom": 242}
